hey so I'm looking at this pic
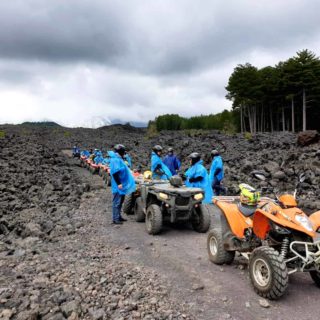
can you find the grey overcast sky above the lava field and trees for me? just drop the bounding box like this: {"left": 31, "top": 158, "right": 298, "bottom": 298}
{"left": 0, "top": 0, "right": 320, "bottom": 126}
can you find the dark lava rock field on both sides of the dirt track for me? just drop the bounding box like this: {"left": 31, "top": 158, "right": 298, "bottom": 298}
{"left": 0, "top": 125, "right": 320, "bottom": 320}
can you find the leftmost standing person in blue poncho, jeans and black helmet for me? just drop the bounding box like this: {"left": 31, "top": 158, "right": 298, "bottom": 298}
{"left": 108, "top": 144, "right": 136, "bottom": 224}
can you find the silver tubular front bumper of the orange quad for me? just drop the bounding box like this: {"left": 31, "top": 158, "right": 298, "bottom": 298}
{"left": 285, "top": 240, "right": 320, "bottom": 274}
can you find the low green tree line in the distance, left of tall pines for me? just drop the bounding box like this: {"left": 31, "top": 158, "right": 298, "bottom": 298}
{"left": 149, "top": 110, "right": 240, "bottom": 132}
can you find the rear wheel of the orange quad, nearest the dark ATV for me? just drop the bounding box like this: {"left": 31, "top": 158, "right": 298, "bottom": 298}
{"left": 207, "top": 229, "right": 235, "bottom": 265}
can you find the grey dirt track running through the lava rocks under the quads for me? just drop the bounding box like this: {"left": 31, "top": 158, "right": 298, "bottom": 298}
{"left": 79, "top": 158, "right": 320, "bottom": 320}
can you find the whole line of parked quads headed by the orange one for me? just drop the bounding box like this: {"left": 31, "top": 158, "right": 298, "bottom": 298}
{"left": 77, "top": 152, "right": 320, "bottom": 299}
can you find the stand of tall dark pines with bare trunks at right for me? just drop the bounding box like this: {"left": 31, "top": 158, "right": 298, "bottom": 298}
{"left": 226, "top": 50, "right": 320, "bottom": 134}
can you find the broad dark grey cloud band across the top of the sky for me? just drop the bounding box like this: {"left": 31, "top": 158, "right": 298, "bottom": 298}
{"left": 0, "top": 0, "right": 320, "bottom": 75}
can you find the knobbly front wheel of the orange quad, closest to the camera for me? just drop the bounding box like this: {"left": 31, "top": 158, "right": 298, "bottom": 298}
{"left": 249, "top": 246, "right": 289, "bottom": 300}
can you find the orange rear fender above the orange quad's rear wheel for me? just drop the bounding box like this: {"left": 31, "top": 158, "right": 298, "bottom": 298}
{"left": 214, "top": 199, "right": 252, "bottom": 238}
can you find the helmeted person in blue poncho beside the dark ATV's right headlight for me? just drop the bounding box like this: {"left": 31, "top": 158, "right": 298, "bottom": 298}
{"left": 185, "top": 152, "right": 213, "bottom": 203}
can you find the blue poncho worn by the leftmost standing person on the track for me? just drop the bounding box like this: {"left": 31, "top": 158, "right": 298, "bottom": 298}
{"left": 108, "top": 151, "right": 136, "bottom": 195}
